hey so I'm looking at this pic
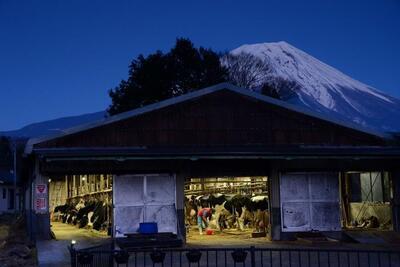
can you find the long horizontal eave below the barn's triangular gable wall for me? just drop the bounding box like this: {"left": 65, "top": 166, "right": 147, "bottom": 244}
{"left": 34, "top": 146, "right": 400, "bottom": 159}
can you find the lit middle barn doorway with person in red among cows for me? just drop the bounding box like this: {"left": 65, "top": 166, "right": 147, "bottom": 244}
{"left": 185, "top": 176, "right": 270, "bottom": 246}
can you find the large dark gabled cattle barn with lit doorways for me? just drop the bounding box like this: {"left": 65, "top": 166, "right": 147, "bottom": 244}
{"left": 25, "top": 83, "right": 400, "bottom": 246}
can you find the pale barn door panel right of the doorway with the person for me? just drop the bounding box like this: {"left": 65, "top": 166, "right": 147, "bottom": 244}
{"left": 280, "top": 172, "right": 341, "bottom": 232}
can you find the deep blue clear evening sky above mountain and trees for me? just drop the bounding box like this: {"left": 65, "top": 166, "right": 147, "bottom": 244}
{"left": 0, "top": 0, "right": 400, "bottom": 130}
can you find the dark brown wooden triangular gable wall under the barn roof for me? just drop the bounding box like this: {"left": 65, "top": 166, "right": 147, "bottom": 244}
{"left": 34, "top": 90, "right": 385, "bottom": 148}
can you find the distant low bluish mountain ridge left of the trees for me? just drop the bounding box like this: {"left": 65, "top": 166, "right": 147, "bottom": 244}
{"left": 0, "top": 111, "right": 106, "bottom": 138}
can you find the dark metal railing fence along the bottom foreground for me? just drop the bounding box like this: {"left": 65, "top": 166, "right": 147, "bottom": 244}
{"left": 69, "top": 247, "right": 400, "bottom": 267}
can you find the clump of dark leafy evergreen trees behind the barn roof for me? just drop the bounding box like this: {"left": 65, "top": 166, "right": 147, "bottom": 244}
{"left": 107, "top": 38, "right": 227, "bottom": 115}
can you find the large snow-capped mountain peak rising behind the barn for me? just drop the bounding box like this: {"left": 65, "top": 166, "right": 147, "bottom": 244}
{"left": 231, "top": 42, "right": 400, "bottom": 131}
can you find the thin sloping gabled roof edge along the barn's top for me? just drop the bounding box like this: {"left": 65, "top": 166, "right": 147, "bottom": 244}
{"left": 25, "top": 83, "right": 389, "bottom": 154}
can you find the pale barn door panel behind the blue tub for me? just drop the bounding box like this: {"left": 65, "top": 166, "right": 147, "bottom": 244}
{"left": 113, "top": 174, "right": 177, "bottom": 237}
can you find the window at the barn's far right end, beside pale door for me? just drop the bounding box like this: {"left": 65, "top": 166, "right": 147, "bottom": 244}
{"left": 348, "top": 172, "right": 390, "bottom": 202}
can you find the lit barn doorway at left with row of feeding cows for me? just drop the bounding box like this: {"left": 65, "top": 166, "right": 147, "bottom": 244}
{"left": 48, "top": 174, "right": 113, "bottom": 244}
